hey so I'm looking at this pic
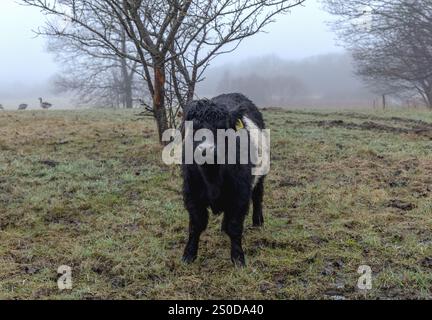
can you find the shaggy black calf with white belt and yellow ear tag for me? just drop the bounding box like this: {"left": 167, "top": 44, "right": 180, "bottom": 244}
{"left": 182, "top": 93, "right": 268, "bottom": 266}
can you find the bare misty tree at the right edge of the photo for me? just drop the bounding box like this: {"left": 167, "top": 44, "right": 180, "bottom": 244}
{"left": 324, "top": 0, "right": 432, "bottom": 108}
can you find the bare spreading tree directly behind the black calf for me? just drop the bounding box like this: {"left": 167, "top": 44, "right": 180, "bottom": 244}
{"left": 22, "top": 0, "right": 305, "bottom": 139}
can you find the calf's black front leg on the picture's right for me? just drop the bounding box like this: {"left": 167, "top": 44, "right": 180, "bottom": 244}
{"left": 224, "top": 205, "right": 248, "bottom": 267}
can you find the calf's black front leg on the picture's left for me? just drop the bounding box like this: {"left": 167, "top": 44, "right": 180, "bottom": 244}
{"left": 183, "top": 208, "right": 208, "bottom": 263}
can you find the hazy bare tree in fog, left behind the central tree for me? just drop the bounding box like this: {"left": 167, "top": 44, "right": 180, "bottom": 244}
{"left": 48, "top": 30, "right": 140, "bottom": 109}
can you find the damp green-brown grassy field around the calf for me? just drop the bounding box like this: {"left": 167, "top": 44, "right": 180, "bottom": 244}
{"left": 0, "top": 110, "right": 432, "bottom": 299}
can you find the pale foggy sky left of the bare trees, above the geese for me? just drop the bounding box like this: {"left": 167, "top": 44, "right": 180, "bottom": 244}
{"left": 0, "top": 0, "right": 69, "bottom": 109}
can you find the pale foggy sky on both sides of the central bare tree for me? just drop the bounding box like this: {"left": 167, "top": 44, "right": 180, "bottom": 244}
{"left": 0, "top": 0, "right": 341, "bottom": 104}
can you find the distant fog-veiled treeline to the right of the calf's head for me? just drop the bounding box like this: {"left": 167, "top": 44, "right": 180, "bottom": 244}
{"left": 198, "top": 54, "right": 378, "bottom": 107}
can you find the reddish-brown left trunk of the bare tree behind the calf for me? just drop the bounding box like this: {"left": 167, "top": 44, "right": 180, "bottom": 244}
{"left": 153, "top": 63, "right": 168, "bottom": 144}
